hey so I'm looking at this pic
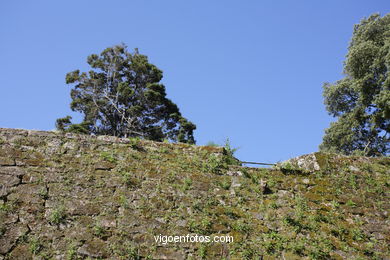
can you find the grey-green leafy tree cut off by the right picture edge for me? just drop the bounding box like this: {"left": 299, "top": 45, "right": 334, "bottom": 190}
{"left": 320, "top": 14, "right": 390, "bottom": 156}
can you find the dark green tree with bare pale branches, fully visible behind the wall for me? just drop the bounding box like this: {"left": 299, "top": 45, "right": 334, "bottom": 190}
{"left": 56, "top": 44, "right": 196, "bottom": 143}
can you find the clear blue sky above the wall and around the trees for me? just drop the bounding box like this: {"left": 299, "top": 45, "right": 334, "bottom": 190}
{"left": 0, "top": 0, "right": 390, "bottom": 162}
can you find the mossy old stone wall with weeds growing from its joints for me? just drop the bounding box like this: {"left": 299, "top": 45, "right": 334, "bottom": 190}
{"left": 0, "top": 129, "right": 390, "bottom": 259}
